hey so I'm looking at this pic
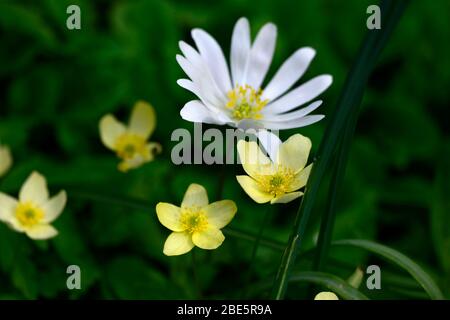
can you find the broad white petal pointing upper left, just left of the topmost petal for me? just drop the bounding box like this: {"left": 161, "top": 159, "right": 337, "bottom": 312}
{"left": 192, "top": 29, "right": 231, "bottom": 92}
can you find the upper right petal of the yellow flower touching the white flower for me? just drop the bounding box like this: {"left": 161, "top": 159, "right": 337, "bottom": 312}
{"left": 277, "top": 134, "right": 311, "bottom": 172}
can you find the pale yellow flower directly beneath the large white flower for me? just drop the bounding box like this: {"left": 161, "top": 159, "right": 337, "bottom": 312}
{"left": 236, "top": 134, "right": 312, "bottom": 204}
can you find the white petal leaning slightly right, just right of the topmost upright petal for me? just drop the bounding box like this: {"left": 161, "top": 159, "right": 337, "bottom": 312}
{"left": 244, "top": 23, "right": 277, "bottom": 89}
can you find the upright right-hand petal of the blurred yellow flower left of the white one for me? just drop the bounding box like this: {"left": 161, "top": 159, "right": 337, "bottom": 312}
{"left": 129, "top": 101, "right": 156, "bottom": 140}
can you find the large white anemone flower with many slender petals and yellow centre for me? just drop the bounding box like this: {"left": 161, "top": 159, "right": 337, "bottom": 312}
{"left": 177, "top": 18, "right": 332, "bottom": 130}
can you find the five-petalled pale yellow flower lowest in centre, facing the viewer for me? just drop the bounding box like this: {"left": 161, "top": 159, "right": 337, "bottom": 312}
{"left": 156, "top": 183, "right": 237, "bottom": 256}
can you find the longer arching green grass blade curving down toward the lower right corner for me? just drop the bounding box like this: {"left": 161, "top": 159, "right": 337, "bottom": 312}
{"left": 332, "top": 239, "right": 444, "bottom": 300}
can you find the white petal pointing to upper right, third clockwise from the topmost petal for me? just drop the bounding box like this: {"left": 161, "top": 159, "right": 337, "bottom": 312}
{"left": 263, "top": 47, "right": 316, "bottom": 100}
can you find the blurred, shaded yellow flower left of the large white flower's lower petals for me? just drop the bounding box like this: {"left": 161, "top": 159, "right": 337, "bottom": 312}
{"left": 100, "top": 101, "right": 161, "bottom": 172}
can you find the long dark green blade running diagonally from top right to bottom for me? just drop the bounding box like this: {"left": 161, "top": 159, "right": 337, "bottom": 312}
{"left": 272, "top": 0, "right": 408, "bottom": 299}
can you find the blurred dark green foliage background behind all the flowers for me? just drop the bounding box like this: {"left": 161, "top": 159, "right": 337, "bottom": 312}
{"left": 0, "top": 0, "right": 450, "bottom": 299}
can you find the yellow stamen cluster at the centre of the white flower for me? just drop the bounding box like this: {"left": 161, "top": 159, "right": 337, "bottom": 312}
{"left": 226, "top": 85, "right": 268, "bottom": 120}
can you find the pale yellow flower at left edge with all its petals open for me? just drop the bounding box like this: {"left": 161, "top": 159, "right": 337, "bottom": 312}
{"left": 0, "top": 172, "right": 67, "bottom": 240}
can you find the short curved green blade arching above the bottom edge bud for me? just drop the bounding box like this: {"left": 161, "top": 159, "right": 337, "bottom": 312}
{"left": 289, "top": 271, "right": 368, "bottom": 300}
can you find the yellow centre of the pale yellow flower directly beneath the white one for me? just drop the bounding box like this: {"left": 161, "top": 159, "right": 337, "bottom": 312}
{"left": 256, "top": 166, "right": 295, "bottom": 197}
